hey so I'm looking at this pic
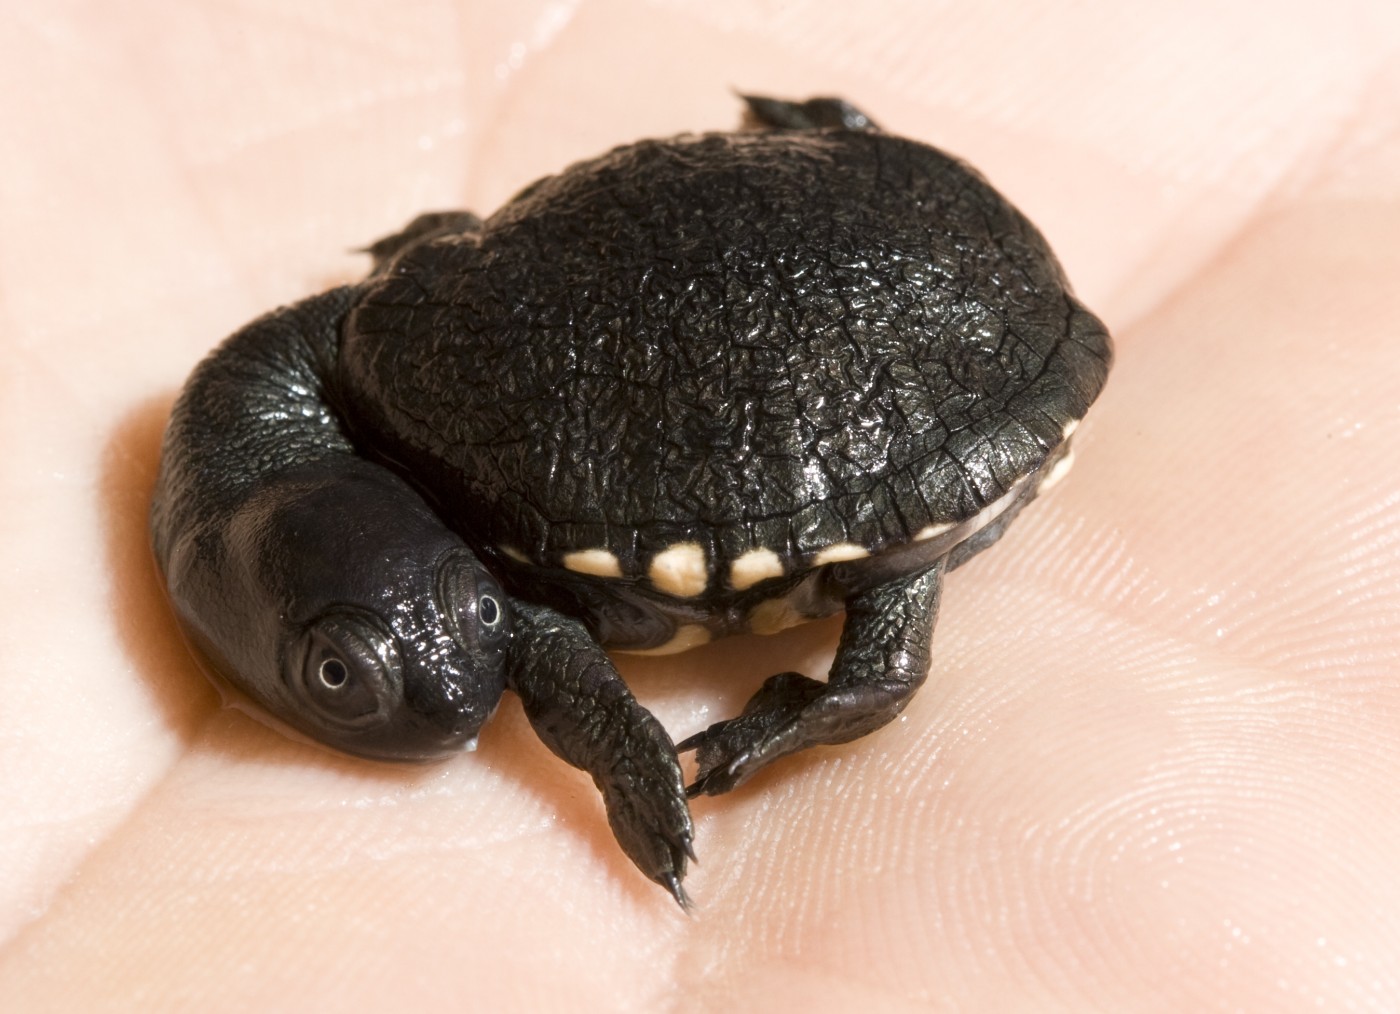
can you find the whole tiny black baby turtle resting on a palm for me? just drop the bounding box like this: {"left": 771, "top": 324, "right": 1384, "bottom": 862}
{"left": 150, "top": 97, "right": 1112, "bottom": 906}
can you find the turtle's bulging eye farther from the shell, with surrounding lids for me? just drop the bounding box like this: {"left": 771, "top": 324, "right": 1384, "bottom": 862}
{"left": 293, "top": 616, "right": 400, "bottom": 728}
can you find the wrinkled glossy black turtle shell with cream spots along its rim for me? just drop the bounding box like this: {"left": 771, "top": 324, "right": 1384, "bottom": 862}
{"left": 340, "top": 130, "right": 1110, "bottom": 613}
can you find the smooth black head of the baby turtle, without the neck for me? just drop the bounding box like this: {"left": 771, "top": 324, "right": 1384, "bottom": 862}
{"left": 167, "top": 462, "right": 511, "bottom": 761}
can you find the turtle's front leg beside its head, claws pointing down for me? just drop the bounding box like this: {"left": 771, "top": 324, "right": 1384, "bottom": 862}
{"left": 505, "top": 601, "right": 694, "bottom": 908}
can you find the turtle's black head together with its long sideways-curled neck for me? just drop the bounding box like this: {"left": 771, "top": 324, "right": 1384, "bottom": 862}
{"left": 151, "top": 289, "right": 510, "bottom": 761}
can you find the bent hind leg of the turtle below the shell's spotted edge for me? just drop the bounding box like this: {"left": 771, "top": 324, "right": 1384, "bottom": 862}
{"left": 678, "top": 560, "right": 945, "bottom": 796}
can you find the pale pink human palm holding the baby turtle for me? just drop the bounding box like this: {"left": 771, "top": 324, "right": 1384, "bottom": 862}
{"left": 0, "top": 0, "right": 1400, "bottom": 1011}
